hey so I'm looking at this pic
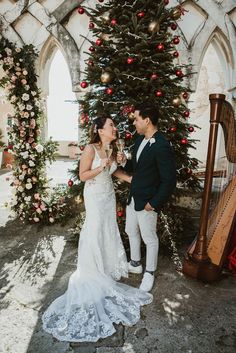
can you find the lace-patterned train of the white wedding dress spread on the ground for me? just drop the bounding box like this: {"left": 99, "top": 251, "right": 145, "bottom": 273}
{"left": 42, "top": 284, "right": 152, "bottom": 342}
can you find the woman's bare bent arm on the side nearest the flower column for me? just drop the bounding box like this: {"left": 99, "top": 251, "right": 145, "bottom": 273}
{"left": 79, "top": 145, "right": 107, "bottom": 181}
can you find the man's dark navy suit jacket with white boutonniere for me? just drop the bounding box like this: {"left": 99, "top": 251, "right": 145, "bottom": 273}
{"left": 124, "top": 131, "right": 176, "bottom": 212}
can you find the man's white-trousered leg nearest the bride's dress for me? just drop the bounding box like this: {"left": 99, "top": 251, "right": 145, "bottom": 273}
{"left": 125, "top": 199, "right": 141, "bottom": 261}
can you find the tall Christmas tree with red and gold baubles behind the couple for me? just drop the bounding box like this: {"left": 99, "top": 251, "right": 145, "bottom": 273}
{"left": 71, "top": 0, "right": 199, "bottom": 253}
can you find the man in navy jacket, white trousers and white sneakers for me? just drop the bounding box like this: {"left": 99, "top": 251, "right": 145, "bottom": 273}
{"left": 117, "top": 103, "right": 176, "bottom": 292}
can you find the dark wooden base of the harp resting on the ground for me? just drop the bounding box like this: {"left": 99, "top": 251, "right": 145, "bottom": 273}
{"left": 183, "top": 255, "right": 221, "bottom": 282}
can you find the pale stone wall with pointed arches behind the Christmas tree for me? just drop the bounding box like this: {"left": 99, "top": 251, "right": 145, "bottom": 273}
{"left": 0, "top": 0, "right": 236, "bottom": 160}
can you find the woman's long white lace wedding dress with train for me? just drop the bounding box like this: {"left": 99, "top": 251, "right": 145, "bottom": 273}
{"left": 42, "top": 146, "right": 152, "bottom": 342}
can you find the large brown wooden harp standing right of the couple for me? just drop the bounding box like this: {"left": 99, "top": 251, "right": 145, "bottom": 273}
{"left": 183, "top": 94, "right": 236, "bottom": 282}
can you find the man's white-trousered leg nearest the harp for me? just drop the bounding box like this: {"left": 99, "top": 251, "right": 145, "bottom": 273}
{"left": 137, "top": 210, "right": 159, "bottom": 272}
